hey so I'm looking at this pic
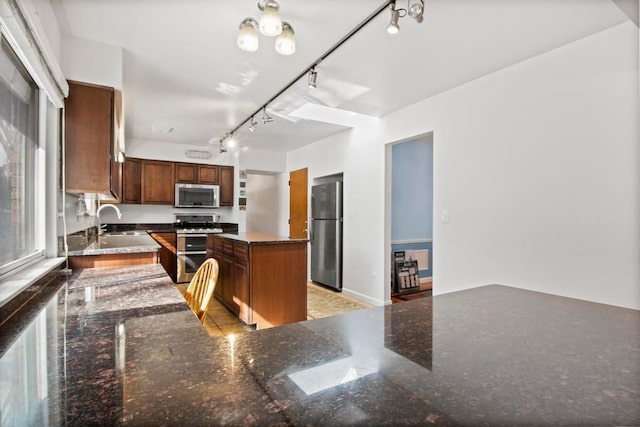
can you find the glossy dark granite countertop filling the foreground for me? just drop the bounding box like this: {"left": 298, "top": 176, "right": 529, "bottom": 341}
{"left": 0, "top": 266, "right": 640, "bottom": 425}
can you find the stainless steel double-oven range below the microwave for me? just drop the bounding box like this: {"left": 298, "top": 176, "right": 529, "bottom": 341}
{"left": 175, "top": 215, "right": 222, "bottom": 283}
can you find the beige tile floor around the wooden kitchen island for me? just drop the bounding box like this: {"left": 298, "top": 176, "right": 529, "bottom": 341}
{"left": 176, "top": 283, "right": 373, "bottom": 337}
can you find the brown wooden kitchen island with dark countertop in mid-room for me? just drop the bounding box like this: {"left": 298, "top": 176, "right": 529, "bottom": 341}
{"left": 207, "top": 233, "right": 307, "bottom": 329}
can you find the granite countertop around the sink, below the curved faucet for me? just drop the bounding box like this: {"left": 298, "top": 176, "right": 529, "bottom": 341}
{"left": 60, "top": 231, "right": 160, "bottom": 256}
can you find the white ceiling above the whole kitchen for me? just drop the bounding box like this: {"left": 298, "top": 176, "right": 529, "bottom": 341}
{"left": 52, "top": 0, "right": 628, "bottom": 151}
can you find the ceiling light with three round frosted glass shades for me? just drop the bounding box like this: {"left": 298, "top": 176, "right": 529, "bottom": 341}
{"left": 237, "top": 0, "right": 296, "bottom": 55}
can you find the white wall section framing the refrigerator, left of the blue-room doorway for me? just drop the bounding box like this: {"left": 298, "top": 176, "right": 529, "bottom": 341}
{"left": 280, "top": 120, "right": 385, "bottom": 304}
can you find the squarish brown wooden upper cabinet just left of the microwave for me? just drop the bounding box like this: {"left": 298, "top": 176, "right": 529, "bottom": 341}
{"left": 140, "top": 160, "right": 175, "bottom": 205}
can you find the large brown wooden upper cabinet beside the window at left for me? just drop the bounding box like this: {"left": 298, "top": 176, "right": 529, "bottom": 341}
{"left": 64, "top": 81, "right": 122, "bottom": 201}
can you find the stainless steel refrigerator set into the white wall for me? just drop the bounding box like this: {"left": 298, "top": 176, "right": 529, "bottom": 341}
{"left": 309, "top": 182, "right": 342, "bottom": 290}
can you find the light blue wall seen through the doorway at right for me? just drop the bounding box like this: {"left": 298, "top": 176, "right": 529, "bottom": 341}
{"left": 391, "top": 141, "right": 433, "bottom": 278}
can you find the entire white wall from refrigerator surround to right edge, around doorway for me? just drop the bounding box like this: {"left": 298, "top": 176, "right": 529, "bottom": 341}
{"left": 281, "top": 22, "right": 640, "bottom": 308}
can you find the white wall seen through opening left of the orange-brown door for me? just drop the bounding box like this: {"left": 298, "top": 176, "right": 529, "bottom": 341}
{"left": 246, "top": 174, "right": 287, "bottom": 235}
